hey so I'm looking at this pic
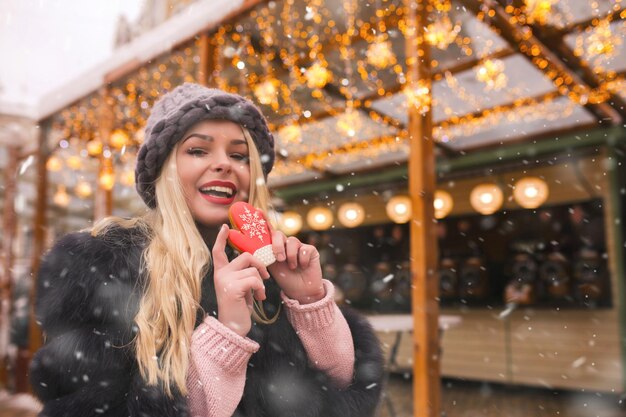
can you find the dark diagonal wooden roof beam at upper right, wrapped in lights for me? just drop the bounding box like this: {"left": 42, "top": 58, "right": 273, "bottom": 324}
{"left": 463, "top": 0, "right": 622, "bottom": 124}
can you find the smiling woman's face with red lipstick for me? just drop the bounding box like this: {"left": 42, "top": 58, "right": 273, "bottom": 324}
{"left": 176, "top": 120, "right": 250, "bottom": 226}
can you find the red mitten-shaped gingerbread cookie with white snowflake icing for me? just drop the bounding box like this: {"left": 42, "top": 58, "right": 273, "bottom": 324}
{"left": 228, "top": 201, "right": 276, "bottom": 266}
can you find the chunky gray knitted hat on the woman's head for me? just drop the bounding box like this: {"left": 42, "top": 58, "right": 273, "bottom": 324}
{"left": 135, "top": 83, "right": 274, "bottom": 208}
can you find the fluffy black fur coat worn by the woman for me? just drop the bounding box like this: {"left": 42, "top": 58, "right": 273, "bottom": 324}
{"left": 30, "top": 228, "right": 383, "bottom": 417}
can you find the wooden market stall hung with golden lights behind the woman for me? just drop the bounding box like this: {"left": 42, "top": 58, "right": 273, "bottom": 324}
{"left": 1, "top": 0, "right": 626, "bottom": 415}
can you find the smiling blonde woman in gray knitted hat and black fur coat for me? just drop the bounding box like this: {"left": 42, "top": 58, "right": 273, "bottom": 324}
{"left": 31, "top": 84, "right": 382, "bottom": 417}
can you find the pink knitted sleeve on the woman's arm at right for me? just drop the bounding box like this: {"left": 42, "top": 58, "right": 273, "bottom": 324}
{"left": 281, "top": 280, "right": 354, "bottom": 388}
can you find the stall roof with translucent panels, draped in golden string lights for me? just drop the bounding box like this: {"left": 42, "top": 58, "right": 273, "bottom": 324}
{"left": 20, "top": 0, "right": 626, "bottom": 210}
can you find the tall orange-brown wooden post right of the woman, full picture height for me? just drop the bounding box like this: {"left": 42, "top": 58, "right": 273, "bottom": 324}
{"left": 405, "top": 0, "right": 441, "bottom": 417}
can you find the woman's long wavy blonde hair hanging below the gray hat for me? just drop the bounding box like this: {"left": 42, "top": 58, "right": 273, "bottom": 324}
{"left": 92, "top": 128, "right": 270, "bottom": 396}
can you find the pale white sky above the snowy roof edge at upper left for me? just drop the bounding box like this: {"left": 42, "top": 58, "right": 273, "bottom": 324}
{"left": 0, "top": 0, "right": 143, "bottom": 106}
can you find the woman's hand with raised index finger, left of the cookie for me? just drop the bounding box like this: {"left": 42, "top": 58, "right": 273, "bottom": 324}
{"left": 212, "top": 225, "right": 270, "bottom": 336}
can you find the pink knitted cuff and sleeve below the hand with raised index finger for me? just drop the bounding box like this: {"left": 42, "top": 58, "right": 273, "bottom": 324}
{"left": 187, "top": 316, "right": 259, "bottom": 417}
